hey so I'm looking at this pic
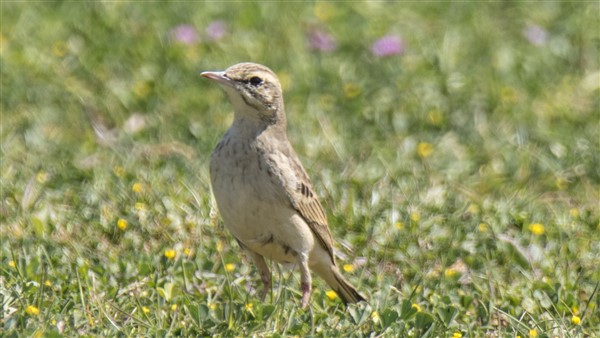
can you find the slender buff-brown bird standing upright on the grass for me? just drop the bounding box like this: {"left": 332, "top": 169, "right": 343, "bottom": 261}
{"left": 201, "top": 62, "right": 366, "bottom": 309}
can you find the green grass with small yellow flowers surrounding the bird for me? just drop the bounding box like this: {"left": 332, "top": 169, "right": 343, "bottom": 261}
{"left": 0, "top": 1, "right": 600, "bottom": 337}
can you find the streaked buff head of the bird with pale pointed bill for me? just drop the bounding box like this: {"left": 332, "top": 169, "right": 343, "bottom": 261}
{"left": 201, "top": 63, "right": 285, "bottom": 123}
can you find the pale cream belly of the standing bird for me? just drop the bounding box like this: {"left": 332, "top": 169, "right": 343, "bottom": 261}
{"left": 211, "top": 144, "right": 314, "bottom": 262}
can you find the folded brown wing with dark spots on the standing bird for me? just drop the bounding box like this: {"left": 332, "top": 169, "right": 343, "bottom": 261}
{"left": 267, "top": 146, "right": 335, "bottom": 262}
